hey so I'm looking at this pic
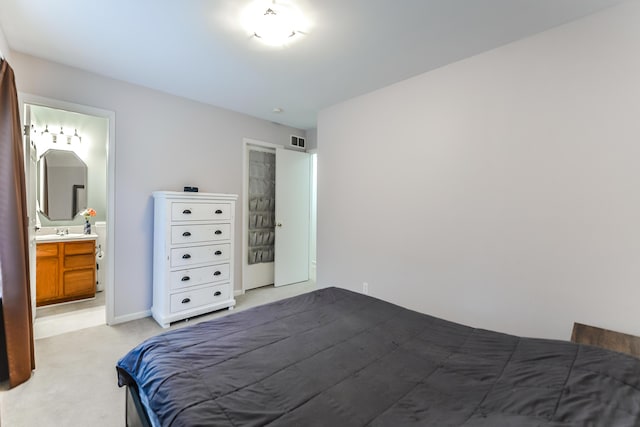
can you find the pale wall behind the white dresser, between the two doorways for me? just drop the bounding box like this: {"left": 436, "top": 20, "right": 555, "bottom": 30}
{"left": 12, "top": 52, "right": 301, "bottom": 321}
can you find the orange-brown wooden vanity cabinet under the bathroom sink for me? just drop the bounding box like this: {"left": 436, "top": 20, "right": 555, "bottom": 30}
{"left": 36, "top": 240, "right": 96, "bottom": 306}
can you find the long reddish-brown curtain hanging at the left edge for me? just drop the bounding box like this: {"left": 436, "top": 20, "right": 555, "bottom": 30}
{"left": 0, "top": 60, "right": 35, "bottom": 387}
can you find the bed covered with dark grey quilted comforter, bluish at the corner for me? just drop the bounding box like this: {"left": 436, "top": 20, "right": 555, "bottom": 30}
{"left": 116, "top": 288, "right": 640, "bottom": 427}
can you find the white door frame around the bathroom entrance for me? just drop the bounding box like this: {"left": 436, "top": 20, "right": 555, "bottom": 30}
{"left": 18, "top": 92, "right": 116, "bottom": 325}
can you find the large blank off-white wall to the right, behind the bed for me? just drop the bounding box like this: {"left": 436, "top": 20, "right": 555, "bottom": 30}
{"left": 318, "top": 2, "right": 640, "bottom": 339}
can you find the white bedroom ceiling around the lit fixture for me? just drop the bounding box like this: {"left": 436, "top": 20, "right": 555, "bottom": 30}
{"left": 0, "top": 0, "right": 623, "bottom": 129}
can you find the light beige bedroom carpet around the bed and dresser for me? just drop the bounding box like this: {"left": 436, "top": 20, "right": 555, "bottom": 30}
{"left": 0, "top": 282, "right": 315, "bottom": 427}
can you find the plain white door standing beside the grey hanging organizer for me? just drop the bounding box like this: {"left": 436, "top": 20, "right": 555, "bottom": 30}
{"left": 274, "top": 148, "right": 311, "bottom": 286}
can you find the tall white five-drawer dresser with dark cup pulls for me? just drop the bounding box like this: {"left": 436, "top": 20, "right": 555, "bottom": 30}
{"left": 151, "top": 191, "right": 238, "bottom": 328}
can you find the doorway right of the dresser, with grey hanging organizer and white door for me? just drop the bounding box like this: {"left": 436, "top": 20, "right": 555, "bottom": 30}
{"left": 242, "top": 139, "right": 315, "bottom": 293}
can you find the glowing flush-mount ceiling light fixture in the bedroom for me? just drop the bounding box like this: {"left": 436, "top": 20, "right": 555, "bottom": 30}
{"left": 243, "top": 0, "right": 304, "bottom": 46}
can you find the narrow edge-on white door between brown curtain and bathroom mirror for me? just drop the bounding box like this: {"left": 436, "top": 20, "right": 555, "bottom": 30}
{"left": 23, "top": 104, "right": 38, "bottom": 319}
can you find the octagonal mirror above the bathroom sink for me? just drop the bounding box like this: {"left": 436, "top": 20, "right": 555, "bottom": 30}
{"left": 38, "top": 150, "right": 87, "bottom": 220}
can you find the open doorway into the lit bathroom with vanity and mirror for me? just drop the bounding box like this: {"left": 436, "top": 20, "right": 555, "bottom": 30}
{"left": 20, "top": 95, "right": 115, "bottom": 339}
